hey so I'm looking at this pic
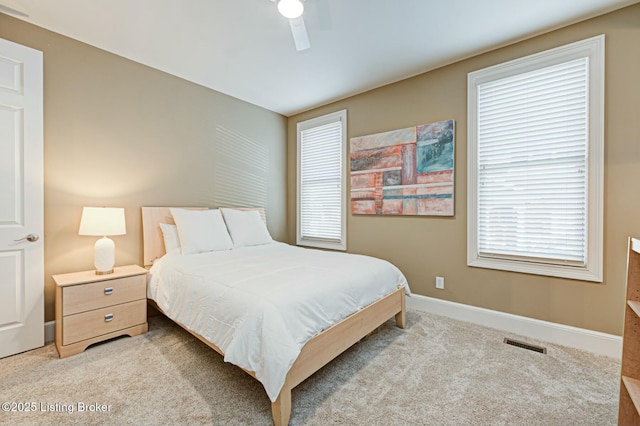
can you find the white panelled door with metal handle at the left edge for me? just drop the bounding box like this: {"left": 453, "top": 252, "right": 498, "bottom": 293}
{"left": 0, "top": 39, "right": 44, "bottom": 358}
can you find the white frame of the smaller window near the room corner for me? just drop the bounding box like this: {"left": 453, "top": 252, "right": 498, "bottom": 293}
{"left": 296, "top": 109, "right": 347, "bottom": 251}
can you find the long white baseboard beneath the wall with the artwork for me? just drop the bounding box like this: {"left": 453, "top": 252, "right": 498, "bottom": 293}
{"left": 407, "top": 294, "right": 622, "bottom": 359}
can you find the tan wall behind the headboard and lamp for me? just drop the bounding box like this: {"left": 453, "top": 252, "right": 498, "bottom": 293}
{"left": 0, "top": 14, "right": 287, "bottom": 321}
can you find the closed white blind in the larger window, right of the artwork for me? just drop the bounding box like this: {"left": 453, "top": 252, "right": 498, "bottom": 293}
{"left": 478, "top": 58, "right": 589, "bottom": 265}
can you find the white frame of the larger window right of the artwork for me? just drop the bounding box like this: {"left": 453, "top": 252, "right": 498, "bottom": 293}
{"left": 467, "top": 35, "right": 605, "bottom": 282}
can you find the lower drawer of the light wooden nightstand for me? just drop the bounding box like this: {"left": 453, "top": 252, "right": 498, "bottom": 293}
{"left": 62, "top": 299, "right": 147, "bottom": 345}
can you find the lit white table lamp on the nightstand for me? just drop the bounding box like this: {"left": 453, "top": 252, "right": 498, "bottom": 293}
{"left": 78, "top": 207, "right": 127, "bottom": 275}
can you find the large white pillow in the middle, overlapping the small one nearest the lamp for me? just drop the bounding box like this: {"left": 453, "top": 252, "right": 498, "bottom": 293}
{"left": 171, "top": 208, "right": 233, "bottom": 254}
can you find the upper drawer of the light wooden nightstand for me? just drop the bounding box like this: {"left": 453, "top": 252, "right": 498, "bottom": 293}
{"left": 62, "top": 275, "right": 147, "bottom": 316}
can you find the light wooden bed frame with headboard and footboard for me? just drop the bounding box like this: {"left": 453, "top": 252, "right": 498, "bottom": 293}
{"left": 142, "top": 207, "right": 406, "bottom": 426}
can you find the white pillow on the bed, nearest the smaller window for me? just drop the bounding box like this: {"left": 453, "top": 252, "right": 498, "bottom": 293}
{"left": 220, "top": 209, "right": 273, "bottom": 247}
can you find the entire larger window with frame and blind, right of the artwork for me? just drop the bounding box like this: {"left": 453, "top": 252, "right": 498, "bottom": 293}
{"left": 467, "top": 36, "right": 604, "bottom": 281}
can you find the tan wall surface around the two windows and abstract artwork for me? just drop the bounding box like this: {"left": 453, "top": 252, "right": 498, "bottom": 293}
{"left": 288, "top": 5, "right": 640, "bottom": 334}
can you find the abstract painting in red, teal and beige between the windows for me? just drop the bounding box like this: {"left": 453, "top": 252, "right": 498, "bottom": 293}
{"left": 350, "top": 120, "right": 455, "bottom": 216}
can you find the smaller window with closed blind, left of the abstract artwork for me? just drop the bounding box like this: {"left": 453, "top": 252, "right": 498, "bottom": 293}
{"left": 296, "top": 110, "right": 347, "bottom": 250}
